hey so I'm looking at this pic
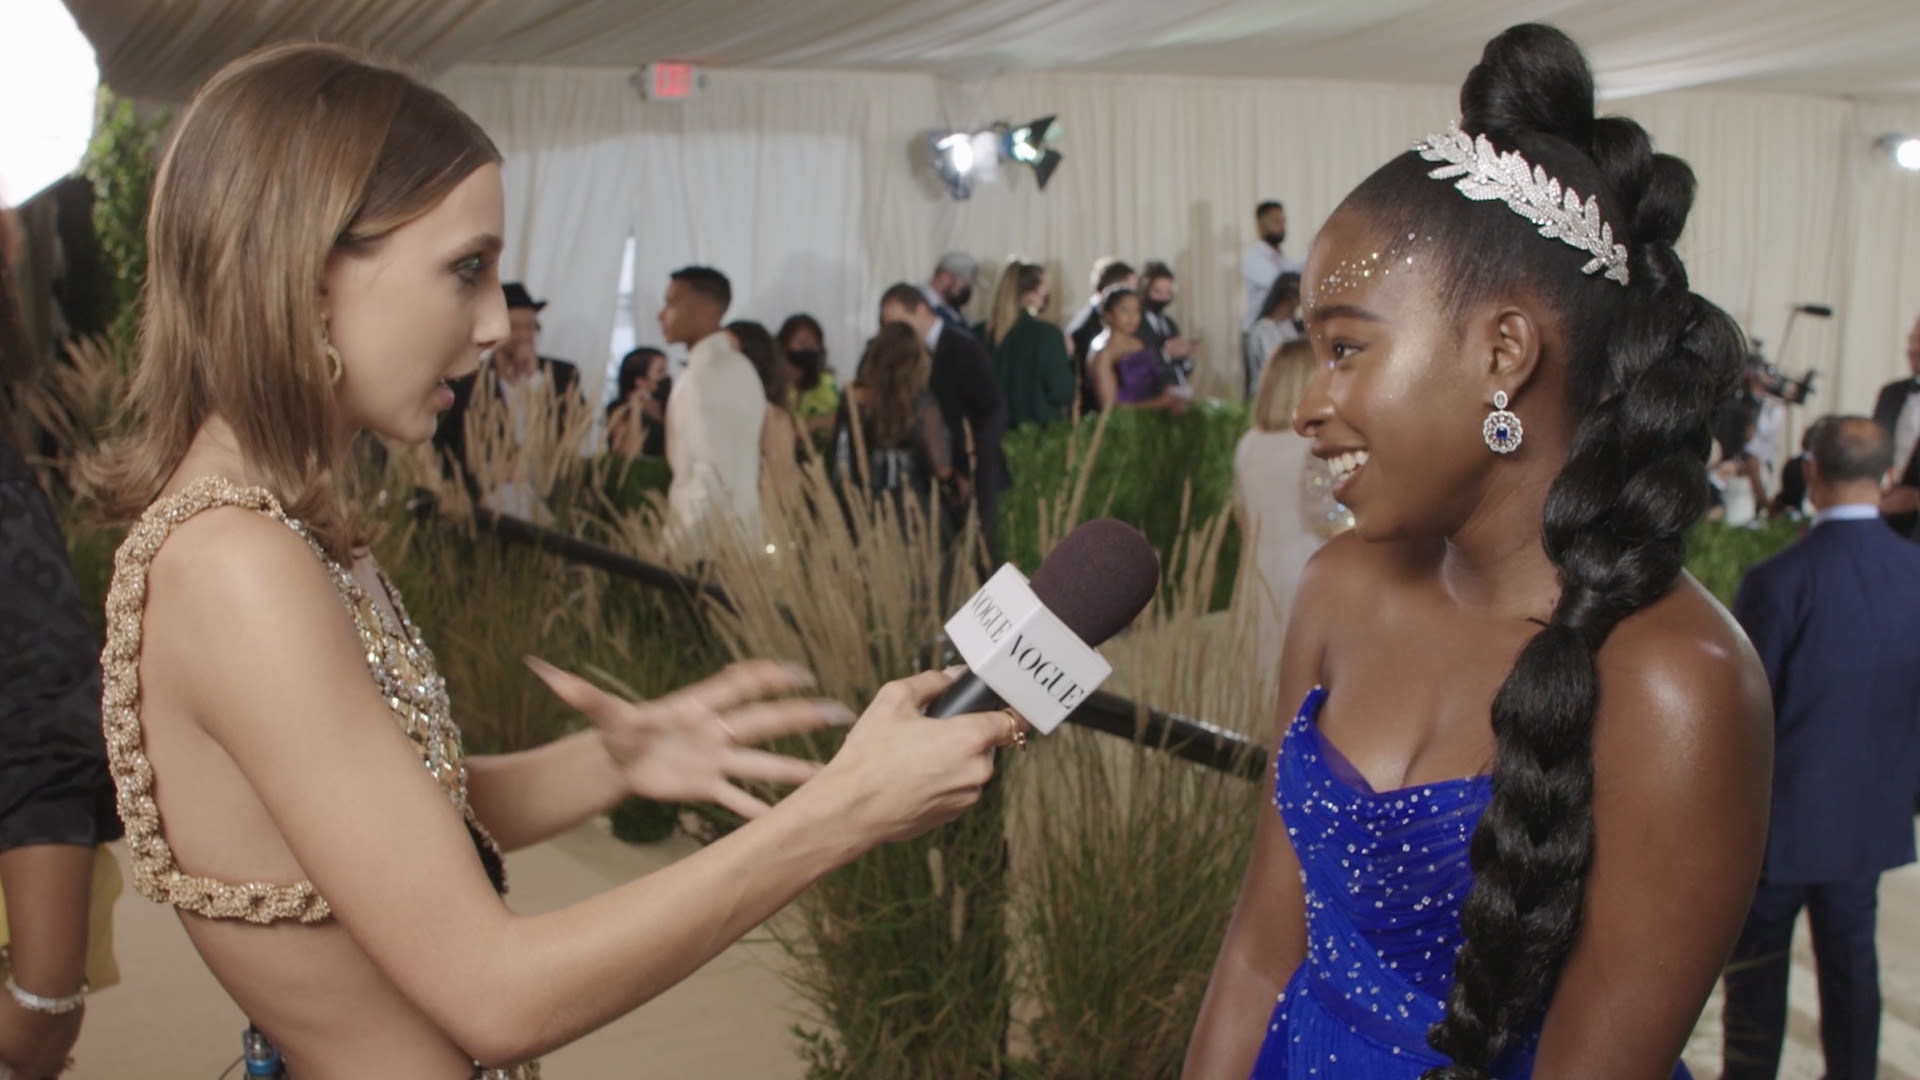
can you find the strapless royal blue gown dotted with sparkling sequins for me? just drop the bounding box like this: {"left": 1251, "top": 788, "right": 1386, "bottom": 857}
{"left": 1252, "top": 688, "right": 1688, "bottom": 1080}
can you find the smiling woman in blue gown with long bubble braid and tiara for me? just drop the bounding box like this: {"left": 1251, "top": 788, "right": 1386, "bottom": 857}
{"left": 1185, "top": 25, "right": 1772, "bottom": 1080}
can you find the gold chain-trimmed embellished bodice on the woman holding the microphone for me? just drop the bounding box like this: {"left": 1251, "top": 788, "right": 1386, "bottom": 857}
{"left": 100, "top": 477, "right": 505, "bottom": 924}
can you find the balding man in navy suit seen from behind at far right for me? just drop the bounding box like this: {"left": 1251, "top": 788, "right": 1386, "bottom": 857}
{"left": 1724, "top": 417, "right": 1920, "bottom": 1080}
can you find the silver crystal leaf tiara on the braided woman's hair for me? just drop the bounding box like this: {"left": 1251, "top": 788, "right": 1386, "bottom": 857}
{"left": 1413, "top": 123, "right": 1630, "bottom": 284}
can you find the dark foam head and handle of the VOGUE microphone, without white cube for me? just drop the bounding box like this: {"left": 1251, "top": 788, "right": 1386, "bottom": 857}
{"left": 927, "top": 517, "right": 1160, "bottom": 717}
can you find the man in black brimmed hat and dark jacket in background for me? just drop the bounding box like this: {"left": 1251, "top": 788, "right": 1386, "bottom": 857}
{"left": 434, "top": 281, "right": 586, "bottom": 509}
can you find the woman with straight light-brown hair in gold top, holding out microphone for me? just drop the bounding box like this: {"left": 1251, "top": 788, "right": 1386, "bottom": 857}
{"left": 92, "top": 44, "right": 1010, "bottom": 1080}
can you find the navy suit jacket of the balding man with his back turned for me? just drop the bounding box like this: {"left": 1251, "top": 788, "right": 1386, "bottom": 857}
{"left": 1734, "top": 519, "right": 1920, "bottom": 884}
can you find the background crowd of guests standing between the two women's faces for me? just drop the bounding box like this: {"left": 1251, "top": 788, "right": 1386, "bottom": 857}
{"left": 434, "top": 204, "right": 1306, "bottom": 568}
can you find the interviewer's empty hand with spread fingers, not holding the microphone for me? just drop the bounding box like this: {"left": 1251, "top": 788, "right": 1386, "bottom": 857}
{"left": 526, "top": 657, "right": 852, "bottom": 819}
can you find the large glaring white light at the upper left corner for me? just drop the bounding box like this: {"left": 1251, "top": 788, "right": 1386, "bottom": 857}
{"left": 0, "top": 0, "right": 100, "bottom": 204}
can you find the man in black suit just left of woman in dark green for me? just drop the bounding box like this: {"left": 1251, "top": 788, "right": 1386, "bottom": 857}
{"left": 879, "top": 284, "right": 1012, "bottom": 561}
